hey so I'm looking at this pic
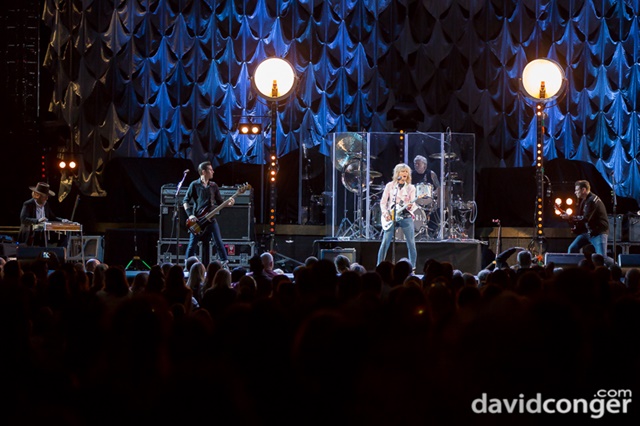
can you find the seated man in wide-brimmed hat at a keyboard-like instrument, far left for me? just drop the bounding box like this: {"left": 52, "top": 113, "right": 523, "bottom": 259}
{"left": 18, "top": 182, "right": 68, "bottom": 246}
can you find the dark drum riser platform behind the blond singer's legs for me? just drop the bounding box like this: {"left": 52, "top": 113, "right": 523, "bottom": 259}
{"left": 314, "top": 239, "right": 488, "bottom": 274}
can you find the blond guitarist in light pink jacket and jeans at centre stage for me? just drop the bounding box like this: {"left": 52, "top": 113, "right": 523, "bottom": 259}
{"left": 378, "top": 163, "right": 420, "bottom": 268}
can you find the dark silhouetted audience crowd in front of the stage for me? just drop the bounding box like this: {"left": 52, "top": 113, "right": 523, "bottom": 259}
{"left": 0, "top": 251, "right": 640, "bottom": 425}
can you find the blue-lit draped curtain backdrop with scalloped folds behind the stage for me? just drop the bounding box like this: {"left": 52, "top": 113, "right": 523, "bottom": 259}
{"left": 43, "top": 0, "right": 640, "bottom": 206}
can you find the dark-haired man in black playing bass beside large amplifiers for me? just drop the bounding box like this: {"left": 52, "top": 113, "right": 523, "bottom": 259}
{"left": 182, "top": 161, "right": 235, "bottom": 265}
